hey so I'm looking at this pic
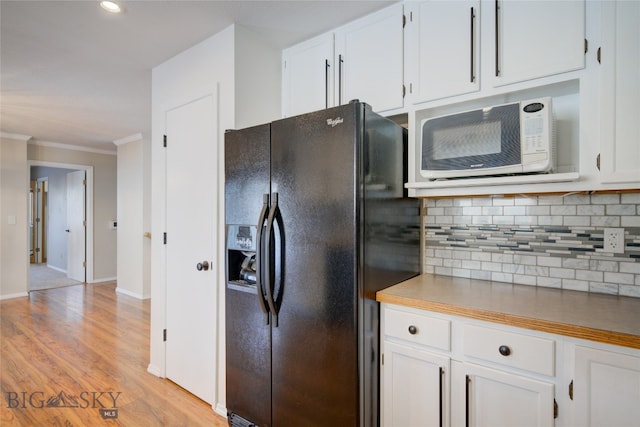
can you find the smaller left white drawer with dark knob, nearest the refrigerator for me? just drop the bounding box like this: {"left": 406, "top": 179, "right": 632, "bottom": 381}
{"left": 383, "top": 308, "right": 451, "bottom": 351}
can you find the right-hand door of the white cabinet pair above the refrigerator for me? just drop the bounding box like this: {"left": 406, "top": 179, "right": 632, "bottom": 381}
{"left": 335, "top": 3, "right": 404, "bottom": 112}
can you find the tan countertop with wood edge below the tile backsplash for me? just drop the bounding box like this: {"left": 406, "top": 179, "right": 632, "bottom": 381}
{"left": 376, "top": 274, "right": 640, "bottom": 349}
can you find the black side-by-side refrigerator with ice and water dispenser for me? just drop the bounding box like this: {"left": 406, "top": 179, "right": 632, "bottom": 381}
{"left": 225, "top": 101, "right": 420, "bottom": 427}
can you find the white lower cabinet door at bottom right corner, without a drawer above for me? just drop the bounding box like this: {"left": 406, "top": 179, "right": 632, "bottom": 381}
{"left": 572, "top": 345, "right": 640, "bottom": 427}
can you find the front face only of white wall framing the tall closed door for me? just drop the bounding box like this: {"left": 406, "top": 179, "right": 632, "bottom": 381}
{"left": 148, "top": 27, "right": 235, "bottom": 418}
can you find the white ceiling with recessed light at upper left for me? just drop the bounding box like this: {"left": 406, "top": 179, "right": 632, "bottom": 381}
{"left": 0, "top": 0, "right": 397, "bottom": 151}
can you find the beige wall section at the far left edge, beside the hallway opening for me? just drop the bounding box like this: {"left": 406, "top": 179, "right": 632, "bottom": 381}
{"left": 0, "top": 134, "right": 29, "bottom": 299}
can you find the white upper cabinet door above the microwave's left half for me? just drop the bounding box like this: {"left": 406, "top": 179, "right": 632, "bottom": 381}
{"left": 405, "top": 0, "right": 480, "bottom": 104}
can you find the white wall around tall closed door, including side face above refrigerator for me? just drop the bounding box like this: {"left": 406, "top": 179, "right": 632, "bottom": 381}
{"left": 148, "top": 26, "right": 280, "bottom": 415}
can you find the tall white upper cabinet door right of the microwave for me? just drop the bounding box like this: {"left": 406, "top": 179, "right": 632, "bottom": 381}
{"left": 600, "top": 1, "right": 640, "bottom": 183}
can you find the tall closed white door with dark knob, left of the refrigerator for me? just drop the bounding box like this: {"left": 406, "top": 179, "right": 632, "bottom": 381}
{"left": 166, "top": 94, "right": 218, "bottom": 403}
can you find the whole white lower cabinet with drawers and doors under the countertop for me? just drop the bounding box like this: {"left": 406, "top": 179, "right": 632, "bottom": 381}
{"left": 380, "top": 303, "right": 640, "bottom": 427}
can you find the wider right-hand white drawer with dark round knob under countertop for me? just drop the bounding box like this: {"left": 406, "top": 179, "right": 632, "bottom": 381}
{"left": 463, "top": 324, "right": 555, "bottom": 376}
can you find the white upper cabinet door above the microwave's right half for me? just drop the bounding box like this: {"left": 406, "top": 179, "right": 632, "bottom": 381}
{"left": 492, "top": 0, "right": 585, "bottom": 86}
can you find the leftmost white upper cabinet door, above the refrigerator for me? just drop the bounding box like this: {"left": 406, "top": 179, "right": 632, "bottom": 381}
{"left": 282, "top": 33, "right": 334, "bottom": 117}
